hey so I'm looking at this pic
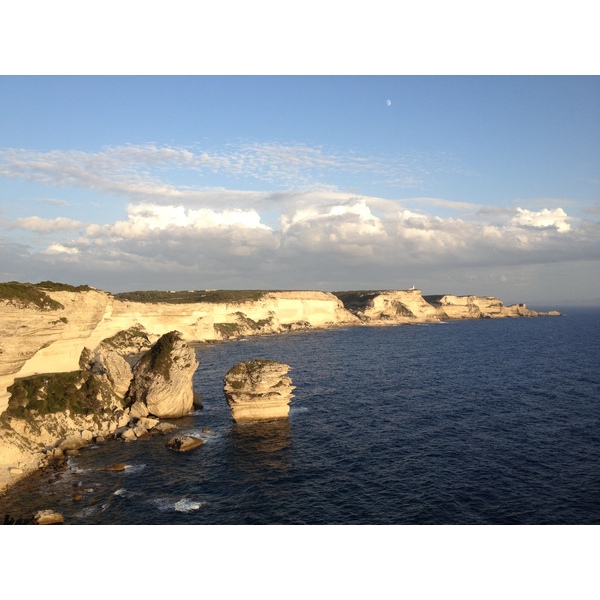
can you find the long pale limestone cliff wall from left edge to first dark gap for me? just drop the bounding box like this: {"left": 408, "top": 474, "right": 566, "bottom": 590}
{"left": 0, "top": 290, "right": 359, "bottom": 413}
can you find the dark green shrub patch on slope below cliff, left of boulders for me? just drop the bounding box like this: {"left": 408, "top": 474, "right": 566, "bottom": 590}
{"left": 3, "top": 371, "right": 111, "bottom": 419}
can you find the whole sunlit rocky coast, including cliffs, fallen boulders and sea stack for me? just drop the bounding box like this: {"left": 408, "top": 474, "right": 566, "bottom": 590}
{"left": 0, "top": 284, "right": 560, "bottom": 502}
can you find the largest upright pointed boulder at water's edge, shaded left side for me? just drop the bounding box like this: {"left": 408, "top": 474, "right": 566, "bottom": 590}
{"left": 128, "top": 331, "right": 198, "bottom": 418}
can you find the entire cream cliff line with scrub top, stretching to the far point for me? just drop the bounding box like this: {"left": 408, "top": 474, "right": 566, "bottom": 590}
{"left": 0, "top": 282, "right": 552, "bottom": 413}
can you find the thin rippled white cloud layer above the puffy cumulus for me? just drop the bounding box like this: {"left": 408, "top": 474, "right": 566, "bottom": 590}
{"left": 0, "top": 144, "right": 435, "bottom": 203}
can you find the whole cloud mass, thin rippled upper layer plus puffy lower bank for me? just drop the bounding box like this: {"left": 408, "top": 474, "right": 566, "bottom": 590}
{"left": 0, "top": 144, "right": 600, "bottom": 302}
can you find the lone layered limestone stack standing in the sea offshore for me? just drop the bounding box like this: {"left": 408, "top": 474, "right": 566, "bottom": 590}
{"left": 223, "top": 358, "right": 295, "bottom": 423}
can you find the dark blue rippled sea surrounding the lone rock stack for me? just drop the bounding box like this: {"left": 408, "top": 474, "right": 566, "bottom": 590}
{"left": 0, "top": 309, "right": 600, "bottom": 525}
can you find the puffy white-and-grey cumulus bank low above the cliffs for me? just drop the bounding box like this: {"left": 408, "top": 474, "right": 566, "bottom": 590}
{"left": 47, "top": 192, "right": 600, "bottom": 272}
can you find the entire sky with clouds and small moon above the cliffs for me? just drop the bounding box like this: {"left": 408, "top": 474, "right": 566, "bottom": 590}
{"left": 0, "top": 76, "right": 600, "bottom": 304}
